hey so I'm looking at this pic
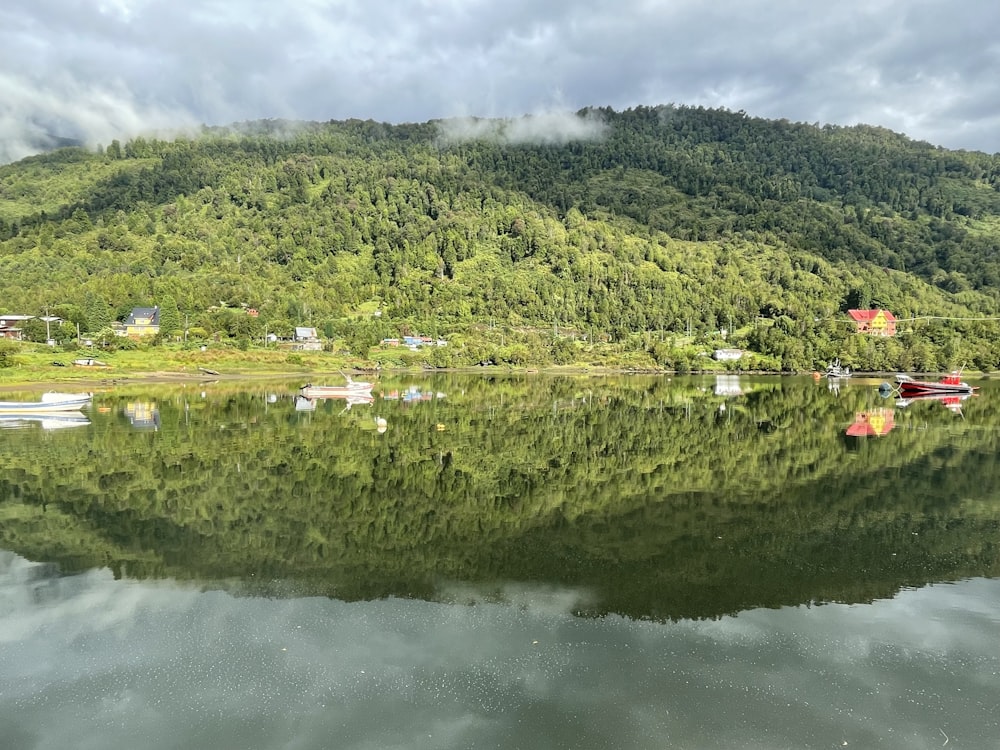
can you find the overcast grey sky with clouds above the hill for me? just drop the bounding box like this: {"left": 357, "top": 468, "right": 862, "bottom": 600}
{"left": 0, "top": 0, "right": 1000, "bottom": 161}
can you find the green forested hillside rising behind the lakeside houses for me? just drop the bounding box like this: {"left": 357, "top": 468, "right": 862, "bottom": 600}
{"left": 0, "top": 106, "right": 1000, "bottom": 370}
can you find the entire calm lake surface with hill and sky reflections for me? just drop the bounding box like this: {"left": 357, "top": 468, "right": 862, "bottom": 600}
{"left": 0, "top": 375, "right": 1000, "bottom": 750}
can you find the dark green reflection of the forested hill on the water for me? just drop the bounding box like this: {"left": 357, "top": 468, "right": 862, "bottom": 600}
{"left": 0, "top": 376, "right": 1000, "bottom": 618}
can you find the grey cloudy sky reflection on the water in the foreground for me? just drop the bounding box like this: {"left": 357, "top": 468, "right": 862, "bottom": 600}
{"left": 0, "top": 552, "right": 1000, "bottom": 750}
